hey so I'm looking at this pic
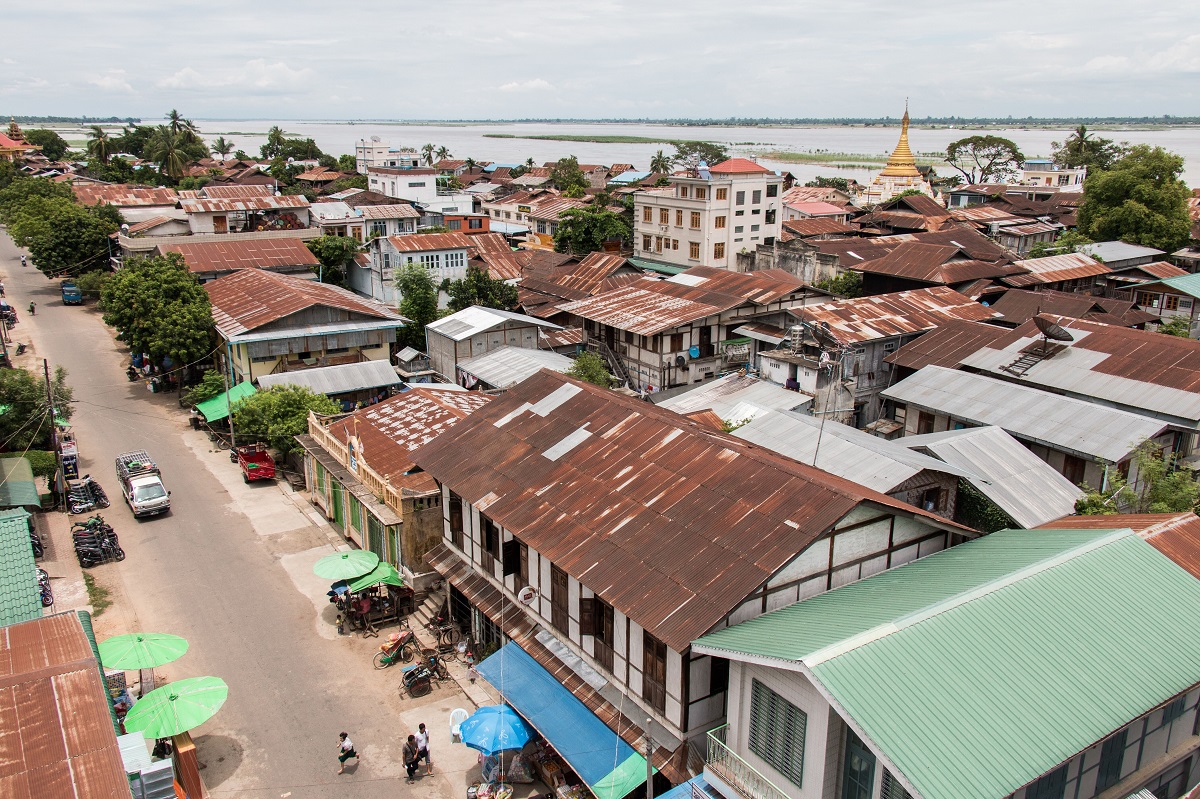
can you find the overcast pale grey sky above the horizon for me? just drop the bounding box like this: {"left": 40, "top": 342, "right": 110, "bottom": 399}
{"left": 0, "top": 0, "right": 1200, "bottom": 120}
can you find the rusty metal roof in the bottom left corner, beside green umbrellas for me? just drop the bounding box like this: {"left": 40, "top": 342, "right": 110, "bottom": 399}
{"left": 0, "top": 612, "right": 130, "bottom": 799}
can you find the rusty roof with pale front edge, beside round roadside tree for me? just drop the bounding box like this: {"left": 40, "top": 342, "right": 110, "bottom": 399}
{"left": 204, "top": 263, "right": 404, "bottom": 338}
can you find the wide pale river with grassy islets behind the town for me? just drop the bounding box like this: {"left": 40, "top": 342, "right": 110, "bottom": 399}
{"left": 189, "top": 120, "right": 1200, "bottom": 186}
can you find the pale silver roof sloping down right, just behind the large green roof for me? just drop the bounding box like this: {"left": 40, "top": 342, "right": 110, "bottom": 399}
{"left": 895, "top": 426, "right": 1084, "bottom": 528}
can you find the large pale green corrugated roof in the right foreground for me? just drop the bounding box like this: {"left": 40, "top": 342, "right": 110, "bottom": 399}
{"left": 696, "top": 530, "right": 1200, "bottom": 799}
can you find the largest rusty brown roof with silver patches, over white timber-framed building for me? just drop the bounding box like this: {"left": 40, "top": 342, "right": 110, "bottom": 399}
{"left": 413, "top": 370, "right": 960, "bottom": 651}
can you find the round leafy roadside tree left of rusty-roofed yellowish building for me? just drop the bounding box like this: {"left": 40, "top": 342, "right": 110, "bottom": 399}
{"left": 100, "top": 253, "right": 214, "bottom": 364}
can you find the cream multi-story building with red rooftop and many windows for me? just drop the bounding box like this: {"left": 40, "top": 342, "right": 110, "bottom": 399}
{"left": 634, "top": 158, "right": 784, "bottom": 269}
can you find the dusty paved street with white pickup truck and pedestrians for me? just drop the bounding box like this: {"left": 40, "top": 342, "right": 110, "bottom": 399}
{"left": 0, "top": 235, "right": 487, "bottom": 799}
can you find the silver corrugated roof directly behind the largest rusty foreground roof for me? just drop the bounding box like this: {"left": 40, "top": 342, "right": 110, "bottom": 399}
{"left": 733, "top": 411, "right": 974, "bottom": 491}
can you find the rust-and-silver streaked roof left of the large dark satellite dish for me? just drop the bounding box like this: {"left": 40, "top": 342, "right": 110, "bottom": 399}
{"left": 791, "top": 286, "right": 991, "bottom": 344}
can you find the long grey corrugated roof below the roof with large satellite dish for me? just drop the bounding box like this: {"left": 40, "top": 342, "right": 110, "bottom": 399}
{"left": 881, "top": 366, "right": 1166, "bottom": 463}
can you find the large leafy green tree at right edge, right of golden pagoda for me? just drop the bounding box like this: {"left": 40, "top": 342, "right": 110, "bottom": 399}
{"left": 1079, "top": 144, "right": 1192, "bottom": 252}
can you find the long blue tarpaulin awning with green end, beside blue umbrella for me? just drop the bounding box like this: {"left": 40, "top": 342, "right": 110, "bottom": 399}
{"left": 479, "top": 642, "right": 646, "bottom": 799}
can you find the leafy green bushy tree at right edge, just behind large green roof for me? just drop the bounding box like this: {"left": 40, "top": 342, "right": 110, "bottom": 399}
{"left": 1075, "top": 441, "right": 1200, "bottom": 516}
